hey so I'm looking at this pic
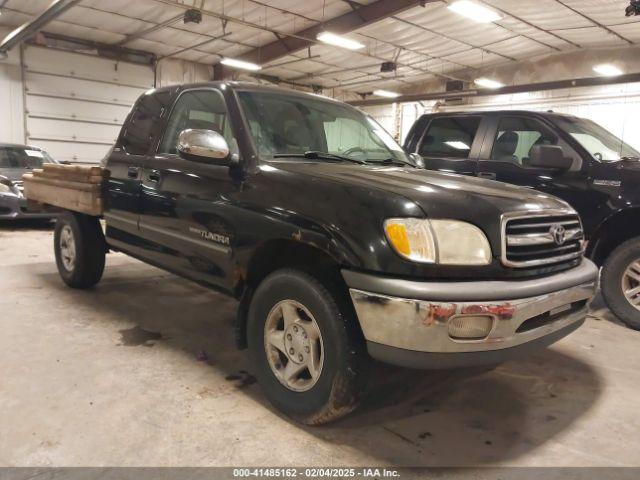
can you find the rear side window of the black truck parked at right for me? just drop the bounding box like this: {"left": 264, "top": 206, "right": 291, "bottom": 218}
{"left": 418, "top": 117, "right": 481, "bottom": 159}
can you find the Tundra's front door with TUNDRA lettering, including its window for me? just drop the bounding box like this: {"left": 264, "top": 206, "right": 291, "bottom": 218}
{"left": 140, "top": 88, "right": 239, "bottom": 288}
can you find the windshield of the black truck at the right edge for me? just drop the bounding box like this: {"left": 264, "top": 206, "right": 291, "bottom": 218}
{"left": 556, "top": 118, "right": 640, "bottom": 162}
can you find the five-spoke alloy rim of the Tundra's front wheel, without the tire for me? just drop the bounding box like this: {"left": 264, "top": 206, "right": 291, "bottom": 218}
{"left": 264, "top": 300, "right": 324, "bottom": 392}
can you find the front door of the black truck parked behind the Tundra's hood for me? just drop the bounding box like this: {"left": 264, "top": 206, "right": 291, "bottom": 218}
{"left": 478, "top": 115, "right": 588, "bottom": 208}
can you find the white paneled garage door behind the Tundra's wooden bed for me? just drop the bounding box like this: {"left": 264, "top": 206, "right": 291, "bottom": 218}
{"left": 24, "top": 46, "right": 153, "bottom": 163}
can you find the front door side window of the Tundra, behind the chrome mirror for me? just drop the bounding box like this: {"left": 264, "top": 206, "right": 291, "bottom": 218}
{"left": 158, "top": 90, "right": 234, "bottom": 153}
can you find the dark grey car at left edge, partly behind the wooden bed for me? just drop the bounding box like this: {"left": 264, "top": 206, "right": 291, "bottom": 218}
{"left": 0, "top": 143, "right": 58, "bottom": 220}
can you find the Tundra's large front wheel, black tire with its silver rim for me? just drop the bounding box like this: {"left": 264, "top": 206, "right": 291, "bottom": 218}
{"left": 247, "top": 269, "right": 369, "bottom": 425}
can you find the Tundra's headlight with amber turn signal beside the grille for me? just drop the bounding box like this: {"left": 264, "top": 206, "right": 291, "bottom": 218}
{"left": 384, "top": 218, "right": 491, "bottom": 265}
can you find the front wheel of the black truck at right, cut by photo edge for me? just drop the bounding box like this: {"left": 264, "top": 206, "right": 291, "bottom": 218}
{"left": 602, "top": 237, "right": 640, "bottom": 330}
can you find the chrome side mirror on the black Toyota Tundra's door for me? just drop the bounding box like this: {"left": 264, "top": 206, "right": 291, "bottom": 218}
{"left": 177, "top": 128, "right": 231, "bottom": 165}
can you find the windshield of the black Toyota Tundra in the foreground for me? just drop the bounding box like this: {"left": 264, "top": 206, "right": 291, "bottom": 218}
{"left": 239, "top": 91, "right": 412, "bottom": 163}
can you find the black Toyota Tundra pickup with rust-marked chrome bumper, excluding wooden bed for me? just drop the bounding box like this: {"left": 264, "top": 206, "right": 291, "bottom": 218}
{"left": 54, "top": 82, "right": 597, "bottom": 424}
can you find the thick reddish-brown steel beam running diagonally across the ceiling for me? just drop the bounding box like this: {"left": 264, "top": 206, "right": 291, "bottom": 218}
{"left": 240, "top": 0, "right": 432, "bottom": 64}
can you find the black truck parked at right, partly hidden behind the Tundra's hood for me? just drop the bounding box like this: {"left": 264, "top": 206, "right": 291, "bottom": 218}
{"left": 404, "top": 111, "right": 640, "bottom": 329}
